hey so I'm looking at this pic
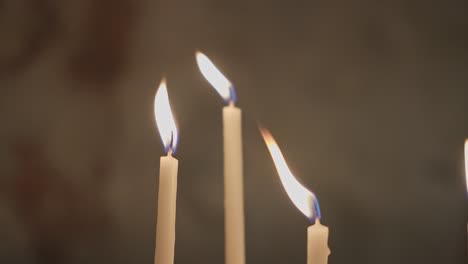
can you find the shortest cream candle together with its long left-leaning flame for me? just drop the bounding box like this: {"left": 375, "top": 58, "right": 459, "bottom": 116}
{"left": 260, "top": 129, "right": 330, "bottom": 264}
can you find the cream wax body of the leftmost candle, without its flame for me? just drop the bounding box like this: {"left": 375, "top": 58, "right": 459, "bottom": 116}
{"left": 154, "top": 156, "right": 178, "bottom": 264}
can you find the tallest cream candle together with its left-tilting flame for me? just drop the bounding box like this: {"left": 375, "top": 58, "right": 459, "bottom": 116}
{"left": 196, "top": 52, "right": 245, "bottom": 264}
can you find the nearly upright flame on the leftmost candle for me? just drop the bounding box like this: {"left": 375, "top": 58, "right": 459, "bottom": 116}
{"left": 154, "top": 79, "right": 178, "bottom": 153}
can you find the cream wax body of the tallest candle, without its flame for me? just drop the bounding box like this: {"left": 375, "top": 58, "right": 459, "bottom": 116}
{"left": 223, "top": 106, "right": 245, "bottom": 264}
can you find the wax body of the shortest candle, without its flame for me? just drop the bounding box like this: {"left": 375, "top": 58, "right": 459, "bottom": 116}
{"left": 307, "top": 220, "right": 330, "bottom": 264}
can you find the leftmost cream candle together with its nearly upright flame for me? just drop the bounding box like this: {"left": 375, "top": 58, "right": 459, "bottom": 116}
{"left": 154, "top": 80, "right": 178, "bottom": 264}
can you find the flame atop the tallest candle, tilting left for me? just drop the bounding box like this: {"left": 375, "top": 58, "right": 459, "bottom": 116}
{"left": 196, "top": 51, "right": 232, "bottom": 101}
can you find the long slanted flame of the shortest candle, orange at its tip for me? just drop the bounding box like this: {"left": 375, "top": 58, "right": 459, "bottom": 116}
{"left": 260, "top": 129, "right": 315, "bottom": 218}
